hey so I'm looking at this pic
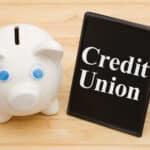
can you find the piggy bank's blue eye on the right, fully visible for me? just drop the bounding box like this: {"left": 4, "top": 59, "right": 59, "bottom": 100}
{"left": 32, "top": 67, "right": 44, "bottom": 80}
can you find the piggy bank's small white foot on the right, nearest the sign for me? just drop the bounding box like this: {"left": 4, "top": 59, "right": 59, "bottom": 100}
{"left": 42, "top": 99, "right": 59, "bottom": 115}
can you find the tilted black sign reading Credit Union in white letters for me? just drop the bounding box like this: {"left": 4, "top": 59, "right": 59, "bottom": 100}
{"left": 67, "top": 12, "right": 150, "bottom": 136}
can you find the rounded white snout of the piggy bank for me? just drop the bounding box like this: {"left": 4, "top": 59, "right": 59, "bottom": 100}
{"left": 8, "top": 83, "right": 39, "bottom": 112}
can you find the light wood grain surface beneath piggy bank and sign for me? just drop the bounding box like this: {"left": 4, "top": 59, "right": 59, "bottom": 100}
{"left": 0, "top": 0, "right": 150, "bottom": 150}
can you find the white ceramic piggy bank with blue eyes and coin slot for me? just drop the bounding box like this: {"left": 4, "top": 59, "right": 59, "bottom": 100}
{"left": 0, "top": 24, "right": 63, "bottom": 123}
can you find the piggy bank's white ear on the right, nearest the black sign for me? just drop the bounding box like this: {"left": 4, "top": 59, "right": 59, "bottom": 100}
{"left": 34, "top": 39, "right": 63, "bottom": 64}
